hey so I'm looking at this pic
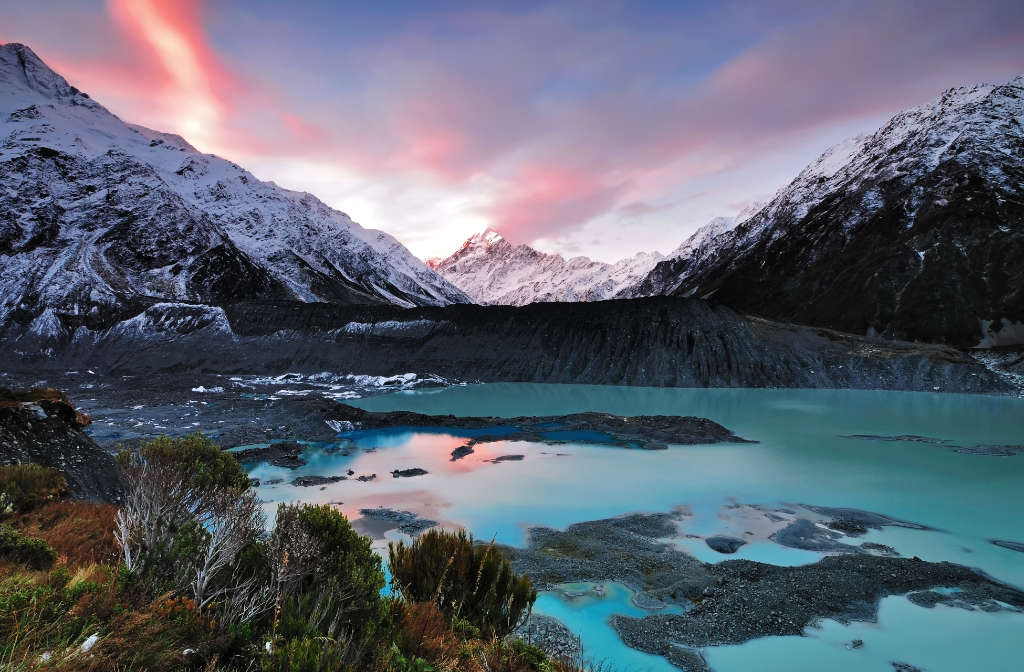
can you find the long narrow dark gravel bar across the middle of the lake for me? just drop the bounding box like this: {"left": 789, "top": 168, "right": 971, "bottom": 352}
{"left": 325, "top": 404, "right": 755, "bottom": 448}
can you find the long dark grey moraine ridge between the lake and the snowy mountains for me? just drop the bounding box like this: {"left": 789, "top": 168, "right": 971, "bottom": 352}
{"left": 0, "top": 297, "right": 1014, "bottom": 392}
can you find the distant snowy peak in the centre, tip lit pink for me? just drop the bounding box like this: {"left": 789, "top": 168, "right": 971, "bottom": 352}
{"left": 428, "top": 228, "right": 665, "bottom": 305}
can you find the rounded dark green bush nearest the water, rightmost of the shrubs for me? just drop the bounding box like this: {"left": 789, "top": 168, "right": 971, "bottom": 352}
{"left": 388, "top": 530, "right": 537, "bottom": 637}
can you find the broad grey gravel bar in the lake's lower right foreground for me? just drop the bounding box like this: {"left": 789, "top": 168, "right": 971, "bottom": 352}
{"left": 505, "top": 514, "right": 1024, "bottom": 669}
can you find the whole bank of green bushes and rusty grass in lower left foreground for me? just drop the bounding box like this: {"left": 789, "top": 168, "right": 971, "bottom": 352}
{"left": 0, "top": 434, "right": 578, "bottom": 672}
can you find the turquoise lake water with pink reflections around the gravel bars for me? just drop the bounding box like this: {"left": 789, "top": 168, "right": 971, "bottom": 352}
{"left": 245, "top": 384, "right": 1024, "bottom": 672}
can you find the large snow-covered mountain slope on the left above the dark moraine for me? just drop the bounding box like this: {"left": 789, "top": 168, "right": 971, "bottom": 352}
{"left": 0, "top": 44, "right": 468, "bottom": 330}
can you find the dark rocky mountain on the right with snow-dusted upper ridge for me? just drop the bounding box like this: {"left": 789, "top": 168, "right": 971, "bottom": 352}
{"left": 630, "top": 77, "right": 1024, "bottom": 346}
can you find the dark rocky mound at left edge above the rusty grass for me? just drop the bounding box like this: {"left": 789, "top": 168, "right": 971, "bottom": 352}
{"left": 0, "top": 388, "right": 123, "bottom": 502}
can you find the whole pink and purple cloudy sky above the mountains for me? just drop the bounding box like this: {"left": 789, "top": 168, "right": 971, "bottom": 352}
{"left": 0, "top": 0, "right": 1024, "bottom": 261}
